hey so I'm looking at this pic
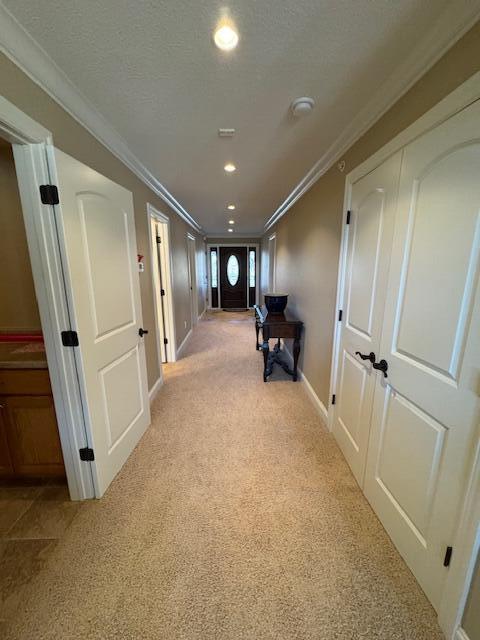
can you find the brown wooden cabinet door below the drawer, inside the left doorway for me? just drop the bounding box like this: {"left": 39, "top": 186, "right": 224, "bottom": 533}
{"left": 2, "top": 396, "right": 65, "bottom": 476}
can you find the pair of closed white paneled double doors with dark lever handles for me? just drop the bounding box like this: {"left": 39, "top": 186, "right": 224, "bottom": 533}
{"left": 333, "top": 102, "right": 480, "bottom": 609}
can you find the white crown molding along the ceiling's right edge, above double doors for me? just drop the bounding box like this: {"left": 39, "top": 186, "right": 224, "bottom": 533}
{"left": 264, "top": 0, "right": 480, "bottom": 231}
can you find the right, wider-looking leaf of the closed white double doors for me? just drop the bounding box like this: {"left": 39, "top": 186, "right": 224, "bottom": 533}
{"left": 365, "top": 102, "right": 480, "bottom": 608}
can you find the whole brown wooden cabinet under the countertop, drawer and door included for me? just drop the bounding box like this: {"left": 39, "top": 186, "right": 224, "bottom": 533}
{"left": 0, "top": 369, "right": 65, "bottom": 477}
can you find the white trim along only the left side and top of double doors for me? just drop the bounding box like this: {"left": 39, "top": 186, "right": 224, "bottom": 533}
{"left": 328, "top": 71, "right": 480, "bottom": 436}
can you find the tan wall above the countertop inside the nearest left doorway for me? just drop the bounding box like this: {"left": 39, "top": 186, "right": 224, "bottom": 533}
{"left": 0, "top": 141, "right": 41, "bottom": 331}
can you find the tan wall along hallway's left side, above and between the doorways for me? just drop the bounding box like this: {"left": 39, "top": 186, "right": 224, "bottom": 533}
{"left": 0, "top": 54, "right": 203, "bottom": 388}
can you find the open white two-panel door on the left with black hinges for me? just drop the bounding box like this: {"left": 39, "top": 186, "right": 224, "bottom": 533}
{"left": 55, "top": 149, "right": 150, "bottom": 497}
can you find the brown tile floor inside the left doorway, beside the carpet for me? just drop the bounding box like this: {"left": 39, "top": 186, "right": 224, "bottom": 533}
{"left": 0, "top": 481, "right": 82, "bottom": 621}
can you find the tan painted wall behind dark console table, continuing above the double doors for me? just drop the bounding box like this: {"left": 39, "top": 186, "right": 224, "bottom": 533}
{"left": 262, "top": 22, "right": 480, "bottom": 406}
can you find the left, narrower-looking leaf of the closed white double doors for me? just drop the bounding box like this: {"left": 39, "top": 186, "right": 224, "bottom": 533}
{"left": 333, "top": 152, "right": 401, "bottom": 486}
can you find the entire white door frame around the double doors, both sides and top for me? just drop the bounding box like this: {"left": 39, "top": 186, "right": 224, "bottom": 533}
{"left": 328, "top": 72, "right": 480, "bottom": 639}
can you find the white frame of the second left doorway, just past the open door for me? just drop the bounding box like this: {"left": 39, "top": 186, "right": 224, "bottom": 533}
{"left": 147, "top": 202, "right": 177, "bottom": 364}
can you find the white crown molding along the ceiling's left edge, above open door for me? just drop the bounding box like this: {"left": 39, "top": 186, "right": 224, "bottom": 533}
{"left": 0, "top": 2, "right": 201, "bottom": 231}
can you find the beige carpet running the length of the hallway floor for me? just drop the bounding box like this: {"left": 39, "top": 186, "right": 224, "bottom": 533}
{"left": 0, "top": 313, "right": 443, "bottom": 640}
